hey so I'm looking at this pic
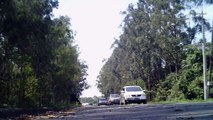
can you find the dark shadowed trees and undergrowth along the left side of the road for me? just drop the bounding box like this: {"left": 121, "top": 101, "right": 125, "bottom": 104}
{"left": 0, "top": 0, "right": 88, "bottom": 108}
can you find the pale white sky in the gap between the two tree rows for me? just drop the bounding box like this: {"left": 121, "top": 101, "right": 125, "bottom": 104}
{"left": 54, "top": 0, "right": 138, "bottom": 97}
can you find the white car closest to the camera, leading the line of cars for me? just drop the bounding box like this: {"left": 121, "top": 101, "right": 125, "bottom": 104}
{"left": 120, "top": 86, "right": 147, "bottom": 104}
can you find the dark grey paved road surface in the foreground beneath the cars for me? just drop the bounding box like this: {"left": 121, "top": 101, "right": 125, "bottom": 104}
{"left": 32, "top": 103, "right": 213, "bottom": 120}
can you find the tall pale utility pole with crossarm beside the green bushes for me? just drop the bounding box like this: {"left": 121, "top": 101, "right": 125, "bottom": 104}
{"left": 201, "top": 10, "right": 208, "bottom": 100}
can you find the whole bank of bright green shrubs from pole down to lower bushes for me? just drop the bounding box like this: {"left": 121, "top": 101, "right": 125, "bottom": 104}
{"left": 156, "top": 45, "right": 209, "bottom": 101}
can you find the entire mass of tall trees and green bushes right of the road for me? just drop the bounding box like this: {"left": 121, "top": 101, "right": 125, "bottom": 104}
{"left": 97, "top": 0, "right": 213, "bottom": 101}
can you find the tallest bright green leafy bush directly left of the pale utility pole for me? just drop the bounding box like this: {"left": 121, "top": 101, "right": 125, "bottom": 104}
{"left": 179, "top": 46, "right": 203, "bottom": 99}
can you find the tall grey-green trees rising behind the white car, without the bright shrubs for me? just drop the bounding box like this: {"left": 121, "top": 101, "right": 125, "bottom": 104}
{"left": 98, "top": 0, "right": 191, "bottom": 99}
